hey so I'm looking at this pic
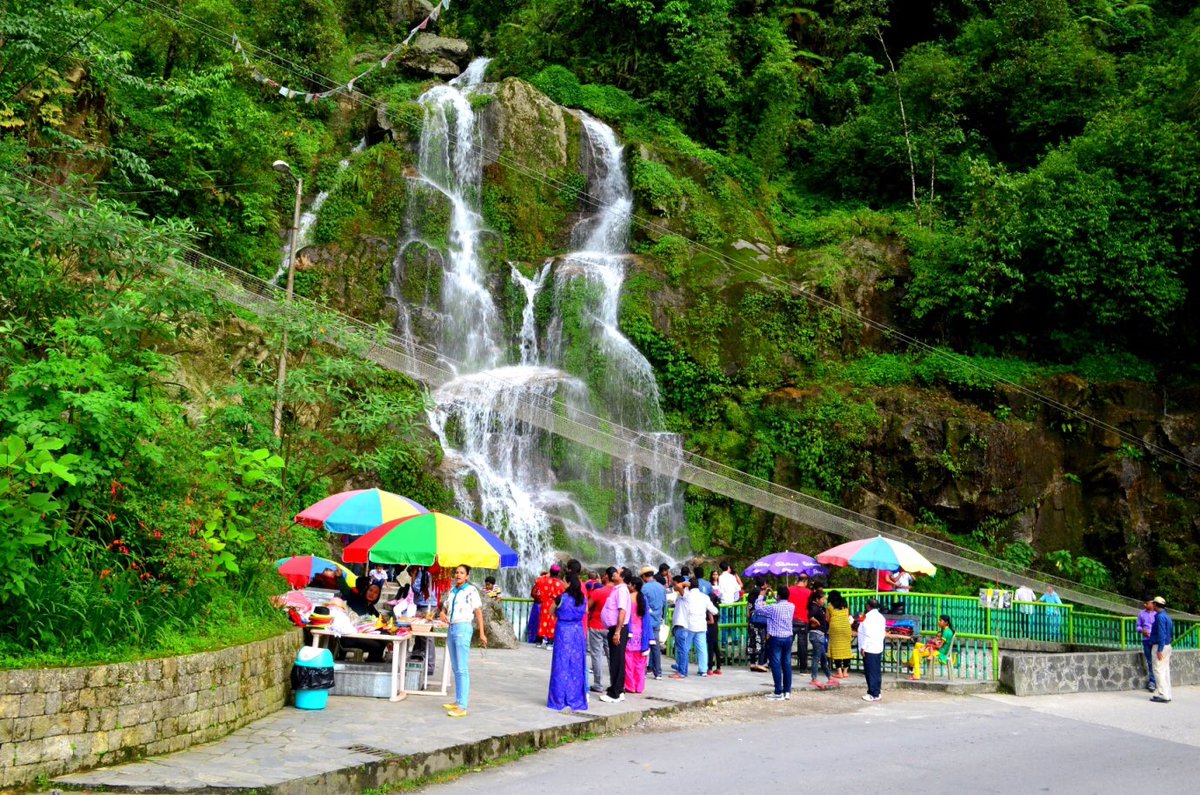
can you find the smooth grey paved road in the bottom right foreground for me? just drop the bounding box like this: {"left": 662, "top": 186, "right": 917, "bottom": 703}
{"left": 427, "top": 687, "right": 1200, "bottom": 795}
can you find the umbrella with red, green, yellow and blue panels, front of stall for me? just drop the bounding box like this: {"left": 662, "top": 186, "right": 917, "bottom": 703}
{"left": 342, "top": 512, "right": 517, "bottom": 569}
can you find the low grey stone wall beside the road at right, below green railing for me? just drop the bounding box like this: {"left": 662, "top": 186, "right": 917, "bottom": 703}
{"left": 1000, "top": 651, "right": 1200, "bottom": 695}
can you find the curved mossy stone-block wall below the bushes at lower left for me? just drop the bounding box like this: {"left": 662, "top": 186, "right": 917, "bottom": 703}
{"left": 0, "top": 630, "right": 301, "bottom": 790}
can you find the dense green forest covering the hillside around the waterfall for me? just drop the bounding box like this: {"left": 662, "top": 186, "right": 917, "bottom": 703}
{"left": 0, "top": 0, "right": 1200, "bottom": 663}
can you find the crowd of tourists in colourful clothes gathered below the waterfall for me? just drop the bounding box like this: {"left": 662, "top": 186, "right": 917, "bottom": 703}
{"left": 295, "top": 560, "right": 1172, "bottom": 717}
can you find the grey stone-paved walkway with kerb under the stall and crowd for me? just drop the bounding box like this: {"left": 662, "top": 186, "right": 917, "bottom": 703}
{"left": 55, "top": 646, "right": 806, "bottom": 795}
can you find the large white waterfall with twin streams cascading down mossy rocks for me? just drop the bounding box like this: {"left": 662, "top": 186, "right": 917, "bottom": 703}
{"left": 400, "top": 59, "right": 683, "bottom": 585}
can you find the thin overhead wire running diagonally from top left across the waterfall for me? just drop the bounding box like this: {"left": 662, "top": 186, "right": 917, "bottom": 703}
{"left": 72, "top": 0, "right": 1200, "bottom": 471}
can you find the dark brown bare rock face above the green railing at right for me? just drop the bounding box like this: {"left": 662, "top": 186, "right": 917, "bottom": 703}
{"left": 844, "top": 376, "right": 1200, "bottom": 587}
